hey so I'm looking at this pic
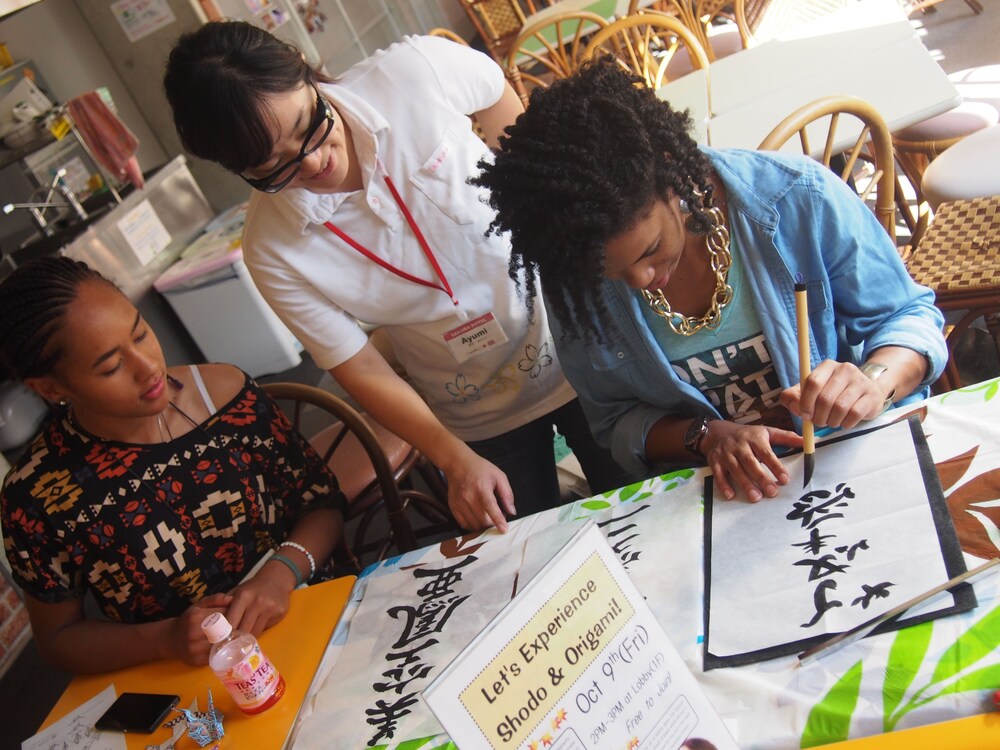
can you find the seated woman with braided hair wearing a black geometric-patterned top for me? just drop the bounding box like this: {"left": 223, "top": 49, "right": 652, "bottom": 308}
{"left": 0, "top": 257, "right": 346, "bottom": 672}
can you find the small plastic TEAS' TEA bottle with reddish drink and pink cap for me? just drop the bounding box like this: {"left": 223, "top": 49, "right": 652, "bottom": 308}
{"left": 201, "top": 612, "right": 285, "bottom": 714}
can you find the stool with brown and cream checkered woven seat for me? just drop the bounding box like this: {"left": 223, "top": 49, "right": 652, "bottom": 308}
{"left": 909, "top": 196, "right": 1000, "bottom": 393}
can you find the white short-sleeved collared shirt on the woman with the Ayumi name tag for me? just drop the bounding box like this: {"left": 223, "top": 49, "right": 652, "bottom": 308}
{"left": 244, "top": 37, "right": 574, "bottom": 440}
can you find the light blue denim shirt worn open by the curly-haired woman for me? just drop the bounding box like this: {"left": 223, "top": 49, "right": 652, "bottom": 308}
{"left": 549, "top": 148, "right": 948, "bottom": 475}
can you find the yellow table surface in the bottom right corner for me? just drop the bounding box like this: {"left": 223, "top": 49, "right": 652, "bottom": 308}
{"left": 822, "top": 713, "right": 1000, "bottom": 750}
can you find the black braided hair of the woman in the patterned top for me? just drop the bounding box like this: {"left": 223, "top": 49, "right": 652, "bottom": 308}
{"left": 0, "top": 257, "right": 114, "bottom": 380}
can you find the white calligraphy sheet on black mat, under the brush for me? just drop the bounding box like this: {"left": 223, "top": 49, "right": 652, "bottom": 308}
{"left": 708, "top": 422, "right": 950, "bottom": 657}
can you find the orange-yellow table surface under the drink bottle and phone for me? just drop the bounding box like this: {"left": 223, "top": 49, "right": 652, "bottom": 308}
{"left": 41, "top": 576, "right": 355, "bottom": 750}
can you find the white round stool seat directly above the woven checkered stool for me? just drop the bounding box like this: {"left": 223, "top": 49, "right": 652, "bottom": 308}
{"left": 922, "top": 125, "right": 1000, "bottom": 210}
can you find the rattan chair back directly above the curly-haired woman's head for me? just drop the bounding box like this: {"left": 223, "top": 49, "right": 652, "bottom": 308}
{"left": 584, "top": 11, "right": 708, "bottom": 89}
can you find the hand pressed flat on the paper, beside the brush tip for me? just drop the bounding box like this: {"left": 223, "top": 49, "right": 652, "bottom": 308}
{"left": 699, "top": 419, "right": 802, "bottom": 503}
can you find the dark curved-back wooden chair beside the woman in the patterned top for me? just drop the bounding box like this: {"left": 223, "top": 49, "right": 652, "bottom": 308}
{"left": 263, "top": 383, "right": 462, "bottom": 566}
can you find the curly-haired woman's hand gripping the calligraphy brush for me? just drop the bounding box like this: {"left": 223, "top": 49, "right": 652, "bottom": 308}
{"left": 779, "top": 359, "right": 886, "bottom": 429}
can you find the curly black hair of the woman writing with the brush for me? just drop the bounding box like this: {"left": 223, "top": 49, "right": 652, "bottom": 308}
{"left": 470, "top": 57, "right": 712, "bottom": 336}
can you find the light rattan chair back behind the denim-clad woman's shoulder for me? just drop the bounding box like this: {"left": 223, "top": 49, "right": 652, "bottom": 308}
{"left": 758, "top": 96, "right": 897, "bottom": 243}
